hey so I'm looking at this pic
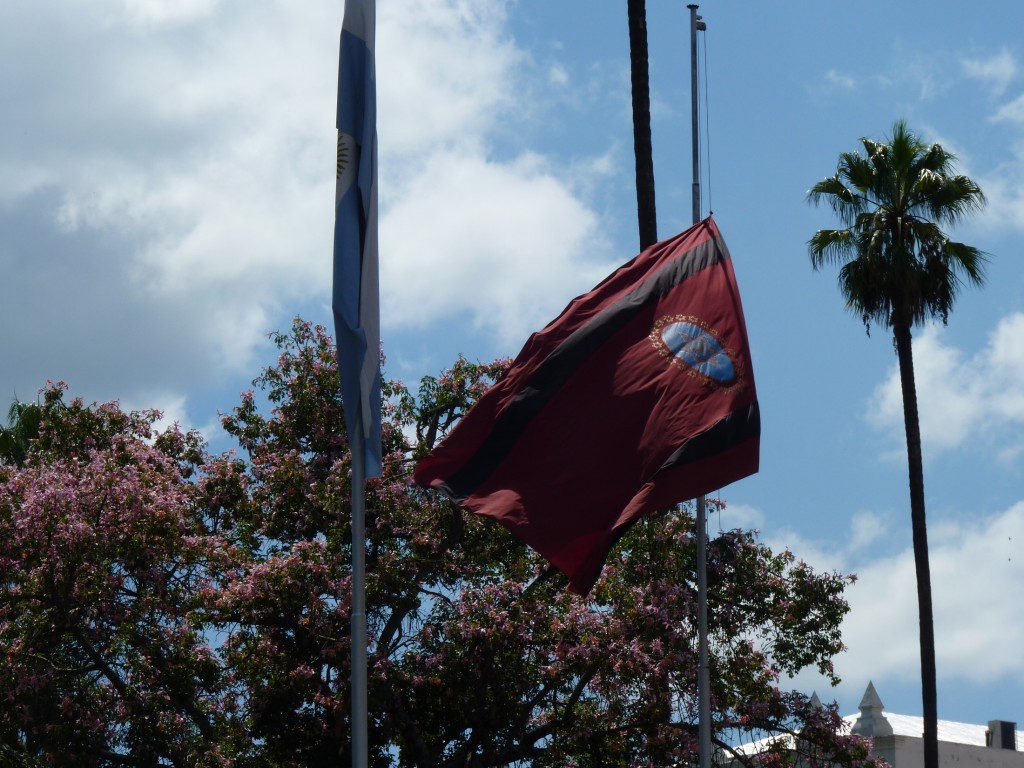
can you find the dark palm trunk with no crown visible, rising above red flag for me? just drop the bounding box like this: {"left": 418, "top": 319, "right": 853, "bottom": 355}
{"left": 627, "top": 0, "right": 657, "bottom": 251}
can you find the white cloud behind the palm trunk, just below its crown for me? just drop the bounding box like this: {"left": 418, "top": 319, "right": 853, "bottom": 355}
{"left": 867, "top": 312, "right": 1024, "bottom": 455}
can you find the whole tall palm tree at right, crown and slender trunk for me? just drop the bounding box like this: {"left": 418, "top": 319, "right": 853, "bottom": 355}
{"left": 807, "top": 121, "right": 986, "bottom": 768}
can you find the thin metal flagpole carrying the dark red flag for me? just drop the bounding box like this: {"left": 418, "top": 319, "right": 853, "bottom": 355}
{"left": 686, "top": 5, "right": 711, "bottom": 768}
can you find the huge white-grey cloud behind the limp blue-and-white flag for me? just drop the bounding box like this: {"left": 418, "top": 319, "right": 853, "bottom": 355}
{"left": 0, "top": 0, "right": 607, "bottom": 410}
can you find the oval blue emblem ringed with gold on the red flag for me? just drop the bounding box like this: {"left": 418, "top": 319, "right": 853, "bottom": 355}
{"left": 648, "top": 314, "right": 745, "bottom": 391}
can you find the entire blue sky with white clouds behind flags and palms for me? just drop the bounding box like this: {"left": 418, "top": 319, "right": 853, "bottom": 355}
{"left": 0, "top": 0, "right": 1024, "bottom": 723}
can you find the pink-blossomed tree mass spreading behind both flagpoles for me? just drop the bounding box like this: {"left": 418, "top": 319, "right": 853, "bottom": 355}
{"left": 0, "top": 321, "right": 880, "bottom": 768}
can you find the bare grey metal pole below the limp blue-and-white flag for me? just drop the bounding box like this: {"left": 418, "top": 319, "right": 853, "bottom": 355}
{"left": 349, "top": 408, "right": 369, "bottom": 768}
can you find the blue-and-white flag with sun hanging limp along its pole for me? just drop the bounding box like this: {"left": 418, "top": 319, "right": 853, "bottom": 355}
{"left": 332, "top": 0, "right": 381, "bottom": 477}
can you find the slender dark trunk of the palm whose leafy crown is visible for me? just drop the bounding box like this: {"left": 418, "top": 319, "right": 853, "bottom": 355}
{"left": 893, "top": 319, "right": 939, "bottom": 768}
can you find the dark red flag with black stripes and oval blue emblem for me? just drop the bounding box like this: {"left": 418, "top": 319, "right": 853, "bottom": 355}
{"left": 415, "top": 218, "right": 761, "bottom": 595}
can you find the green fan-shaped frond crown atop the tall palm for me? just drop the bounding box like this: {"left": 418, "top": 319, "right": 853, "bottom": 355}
{"left": 807, "top": 121, "right": 986, "bottom": 328}
